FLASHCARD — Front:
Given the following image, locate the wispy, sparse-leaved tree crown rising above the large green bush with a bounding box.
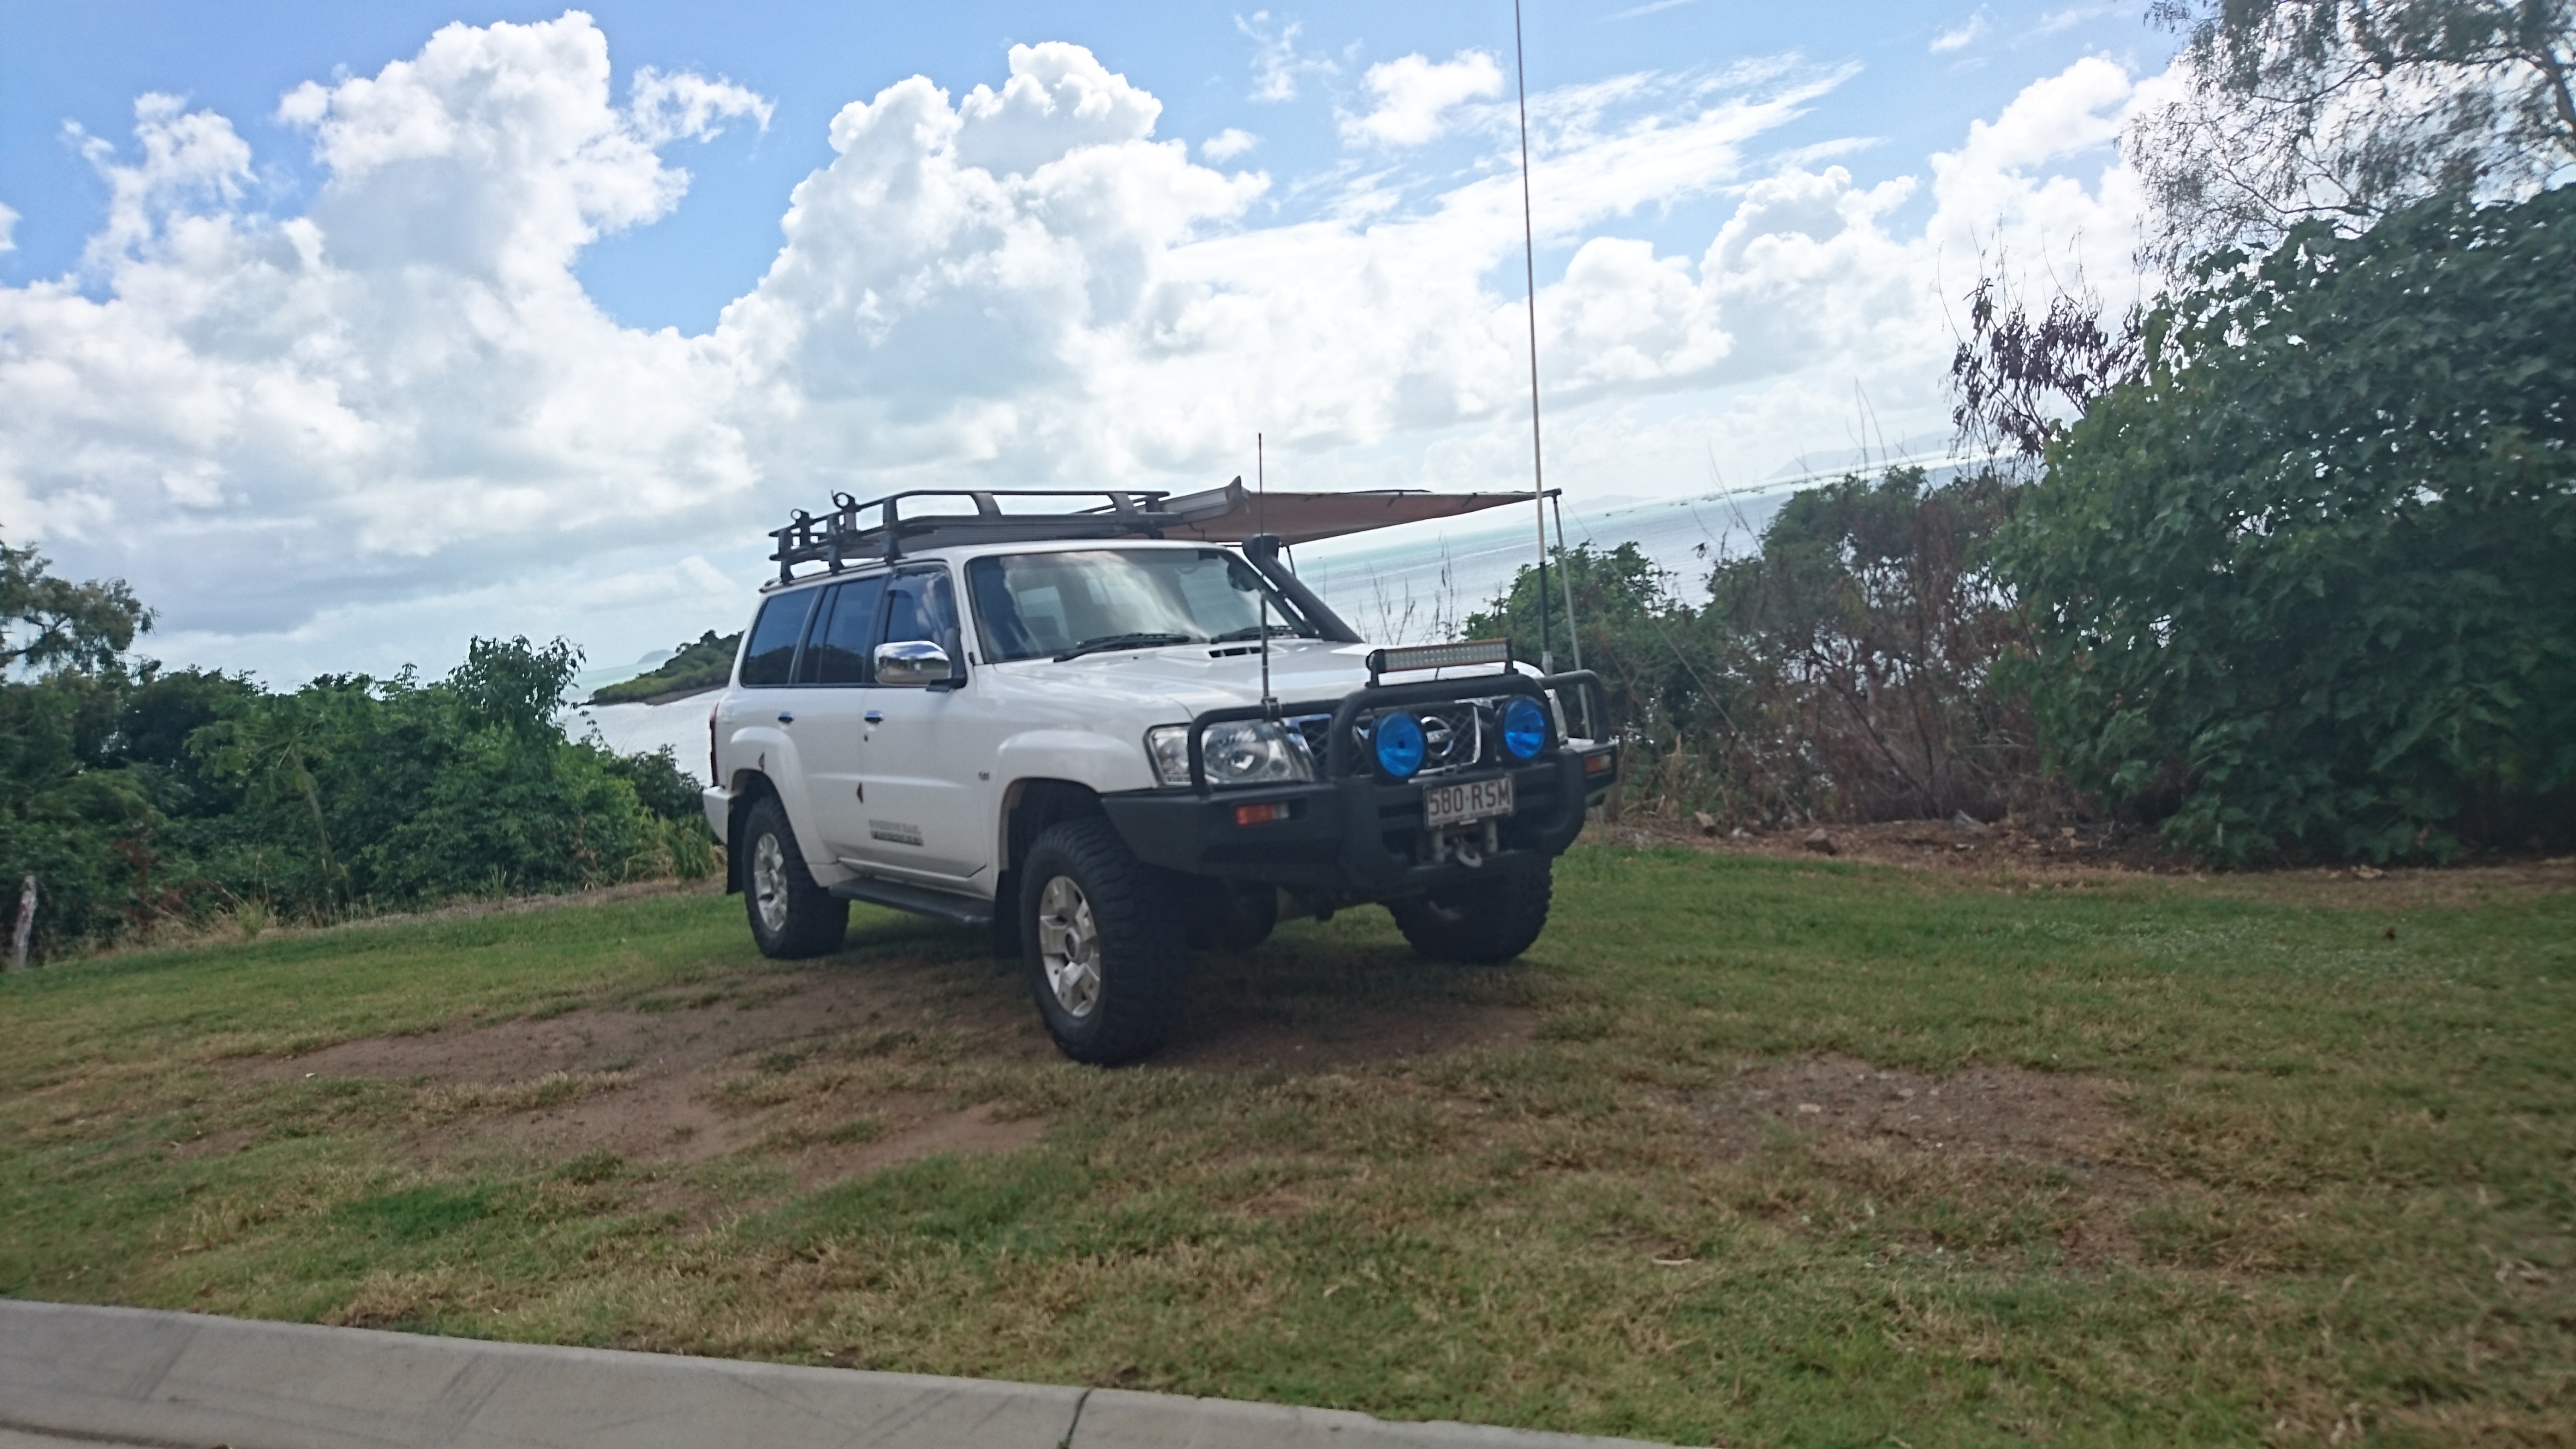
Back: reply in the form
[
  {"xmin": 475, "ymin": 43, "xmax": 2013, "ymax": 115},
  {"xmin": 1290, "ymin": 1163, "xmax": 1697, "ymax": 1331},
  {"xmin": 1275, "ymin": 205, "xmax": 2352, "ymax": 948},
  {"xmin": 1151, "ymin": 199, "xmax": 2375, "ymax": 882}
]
[{"xmin": 2128, "ymin": 0, "xmax": 2576, "ymax": 278}]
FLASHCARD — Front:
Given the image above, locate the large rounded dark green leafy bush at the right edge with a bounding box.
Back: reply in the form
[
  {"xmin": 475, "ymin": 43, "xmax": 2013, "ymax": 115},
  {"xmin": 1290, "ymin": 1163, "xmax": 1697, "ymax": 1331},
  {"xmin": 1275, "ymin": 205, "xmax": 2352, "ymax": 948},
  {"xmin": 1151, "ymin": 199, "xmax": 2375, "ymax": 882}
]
[{"xmin": 2004, "ymin": 191, "xmax": 2576, "ymax": 861}]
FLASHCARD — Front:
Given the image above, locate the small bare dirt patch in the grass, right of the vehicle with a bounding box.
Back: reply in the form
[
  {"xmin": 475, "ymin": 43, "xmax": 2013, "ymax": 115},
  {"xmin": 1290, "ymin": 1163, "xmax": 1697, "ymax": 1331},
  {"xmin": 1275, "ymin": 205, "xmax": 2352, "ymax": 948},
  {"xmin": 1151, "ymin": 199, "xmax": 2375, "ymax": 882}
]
[{"xmin": 1703, "ymin": 1041, "xmax": 2128, "ymax": 1168}]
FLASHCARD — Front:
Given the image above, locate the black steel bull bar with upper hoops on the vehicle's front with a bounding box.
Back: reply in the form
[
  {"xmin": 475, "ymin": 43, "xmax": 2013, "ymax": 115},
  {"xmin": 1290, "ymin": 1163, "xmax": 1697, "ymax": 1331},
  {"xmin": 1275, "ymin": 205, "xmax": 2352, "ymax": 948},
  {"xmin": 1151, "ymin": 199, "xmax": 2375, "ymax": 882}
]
[{"xmin": 1100, "ymin": 670, "xmax": 1618, "ymax": 905}]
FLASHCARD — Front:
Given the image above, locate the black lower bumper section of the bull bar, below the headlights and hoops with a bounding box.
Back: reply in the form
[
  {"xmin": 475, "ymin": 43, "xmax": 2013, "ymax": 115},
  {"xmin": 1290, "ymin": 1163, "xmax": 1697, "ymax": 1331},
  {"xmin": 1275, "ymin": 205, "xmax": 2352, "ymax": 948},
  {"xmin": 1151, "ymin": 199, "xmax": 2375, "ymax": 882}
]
[{"xmin": 1100, "ymin": 745, "xmax": 1618, "ymax": 902}]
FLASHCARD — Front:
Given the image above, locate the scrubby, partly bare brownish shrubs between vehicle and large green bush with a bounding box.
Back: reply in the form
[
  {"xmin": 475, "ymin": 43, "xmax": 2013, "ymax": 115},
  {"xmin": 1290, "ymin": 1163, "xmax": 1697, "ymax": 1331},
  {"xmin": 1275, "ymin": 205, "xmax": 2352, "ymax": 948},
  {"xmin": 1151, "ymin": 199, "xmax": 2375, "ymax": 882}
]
[{"xmin": 1466, "ymin": 467, "xmax": 2037, "ymax": 825}]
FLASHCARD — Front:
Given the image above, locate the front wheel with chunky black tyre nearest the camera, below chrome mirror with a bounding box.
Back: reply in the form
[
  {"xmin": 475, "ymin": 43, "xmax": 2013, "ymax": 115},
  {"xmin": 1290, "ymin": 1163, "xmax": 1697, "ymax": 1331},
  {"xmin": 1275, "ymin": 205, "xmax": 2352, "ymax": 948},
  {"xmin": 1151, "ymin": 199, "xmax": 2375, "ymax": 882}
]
[{"xmin": 1020, "ymin": 815, "xmax": 1187, "ymax": 1067}]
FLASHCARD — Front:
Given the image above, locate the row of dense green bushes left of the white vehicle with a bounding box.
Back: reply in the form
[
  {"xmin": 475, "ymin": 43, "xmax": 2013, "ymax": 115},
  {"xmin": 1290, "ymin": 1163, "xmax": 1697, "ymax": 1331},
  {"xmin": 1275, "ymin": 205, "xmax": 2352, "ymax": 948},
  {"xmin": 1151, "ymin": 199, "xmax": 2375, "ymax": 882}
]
[{"xmin": 0, "ymin": 549, "xmax": 714, "ymax": 954}]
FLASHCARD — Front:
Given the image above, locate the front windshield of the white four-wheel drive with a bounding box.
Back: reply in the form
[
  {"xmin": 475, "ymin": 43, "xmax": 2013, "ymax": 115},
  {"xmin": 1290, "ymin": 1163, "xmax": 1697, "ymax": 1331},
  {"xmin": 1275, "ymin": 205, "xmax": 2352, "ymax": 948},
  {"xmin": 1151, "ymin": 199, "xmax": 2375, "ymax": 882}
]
[{"xmin": 966, "ymin": 549, "xmax": 1319, "ymax": 663}]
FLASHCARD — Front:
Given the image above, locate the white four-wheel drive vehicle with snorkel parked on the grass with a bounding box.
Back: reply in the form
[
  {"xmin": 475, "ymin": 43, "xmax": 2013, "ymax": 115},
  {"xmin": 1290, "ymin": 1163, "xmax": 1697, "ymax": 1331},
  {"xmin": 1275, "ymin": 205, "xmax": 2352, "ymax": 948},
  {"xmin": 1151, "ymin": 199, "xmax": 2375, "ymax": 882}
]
[{"xmin": 706, "ymin": 480, "xmax": 1618, "ymax": 1062}]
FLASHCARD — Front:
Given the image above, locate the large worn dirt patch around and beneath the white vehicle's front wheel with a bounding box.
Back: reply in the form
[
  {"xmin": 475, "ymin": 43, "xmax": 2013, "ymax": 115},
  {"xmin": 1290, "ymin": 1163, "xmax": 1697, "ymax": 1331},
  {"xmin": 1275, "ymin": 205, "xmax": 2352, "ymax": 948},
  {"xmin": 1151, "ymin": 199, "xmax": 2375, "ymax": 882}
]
[{"xmin": 239, "ymin": 943, "xmax": 1538, "ymax": 1196}]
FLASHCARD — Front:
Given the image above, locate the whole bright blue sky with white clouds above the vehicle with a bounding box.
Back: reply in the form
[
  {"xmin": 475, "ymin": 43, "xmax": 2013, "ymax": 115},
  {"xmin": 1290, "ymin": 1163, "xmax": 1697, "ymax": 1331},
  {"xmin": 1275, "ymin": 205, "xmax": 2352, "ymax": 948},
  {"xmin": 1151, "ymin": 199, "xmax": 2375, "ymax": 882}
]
[{"xmin": 0, "ymin": 0, "xmax": 2174, "ymax": 686}]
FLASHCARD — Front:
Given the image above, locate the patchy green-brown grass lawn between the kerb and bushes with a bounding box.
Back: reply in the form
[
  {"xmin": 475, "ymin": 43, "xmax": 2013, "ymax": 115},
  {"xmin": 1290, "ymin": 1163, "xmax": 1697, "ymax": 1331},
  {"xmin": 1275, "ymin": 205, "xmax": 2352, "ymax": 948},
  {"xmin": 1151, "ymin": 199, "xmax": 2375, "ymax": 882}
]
[{"xmin": 0, "ymin": 846, "xmax": 2576, "ymax": 1446}]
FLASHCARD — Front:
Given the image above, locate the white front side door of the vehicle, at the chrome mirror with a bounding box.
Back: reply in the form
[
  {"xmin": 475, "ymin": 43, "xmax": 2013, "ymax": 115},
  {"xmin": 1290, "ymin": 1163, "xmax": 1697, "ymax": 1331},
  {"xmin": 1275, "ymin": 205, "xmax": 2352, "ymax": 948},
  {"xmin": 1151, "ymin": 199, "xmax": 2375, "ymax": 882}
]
[{"xmin": 858, "ymin": 565, "xmax": 994, "ymax": 887}]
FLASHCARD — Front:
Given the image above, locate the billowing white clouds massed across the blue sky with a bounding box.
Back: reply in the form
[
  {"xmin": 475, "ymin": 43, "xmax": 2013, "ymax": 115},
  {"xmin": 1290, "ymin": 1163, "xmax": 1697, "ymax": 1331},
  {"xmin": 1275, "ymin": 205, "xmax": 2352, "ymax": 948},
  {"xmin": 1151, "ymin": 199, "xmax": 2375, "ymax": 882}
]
[{"xmin": 0, "ymin": 15, "xmax": 2161, "ymax": 673}]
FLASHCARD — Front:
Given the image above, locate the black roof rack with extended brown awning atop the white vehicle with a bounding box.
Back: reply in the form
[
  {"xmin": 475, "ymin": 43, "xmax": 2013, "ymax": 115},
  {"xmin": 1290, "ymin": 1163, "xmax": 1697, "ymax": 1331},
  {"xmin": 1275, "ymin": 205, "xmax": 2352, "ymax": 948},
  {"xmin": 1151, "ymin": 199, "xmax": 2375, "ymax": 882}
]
[{"xmin": 770, "ymin": 477, "xmax": 1530, "ymax": 588}]
